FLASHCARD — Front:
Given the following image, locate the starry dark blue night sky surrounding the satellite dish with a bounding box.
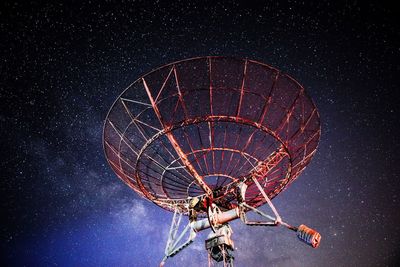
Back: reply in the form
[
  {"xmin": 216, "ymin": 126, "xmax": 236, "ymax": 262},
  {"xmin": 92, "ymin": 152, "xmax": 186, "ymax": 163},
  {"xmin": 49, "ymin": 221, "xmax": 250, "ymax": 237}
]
[{"xmin": 0, "ymin": 1, "xmax": 400, "ymax": 266}]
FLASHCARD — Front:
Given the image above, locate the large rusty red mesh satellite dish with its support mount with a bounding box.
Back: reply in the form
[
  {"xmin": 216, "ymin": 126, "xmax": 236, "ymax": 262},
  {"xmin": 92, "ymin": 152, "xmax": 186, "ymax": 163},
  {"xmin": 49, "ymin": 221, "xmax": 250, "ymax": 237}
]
[{"xmin": 104, "ymin": 57, "xmax": 321, "ymax": 266}]
